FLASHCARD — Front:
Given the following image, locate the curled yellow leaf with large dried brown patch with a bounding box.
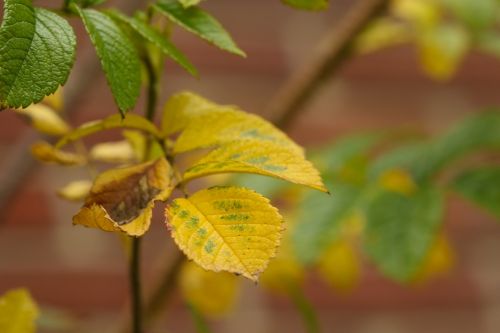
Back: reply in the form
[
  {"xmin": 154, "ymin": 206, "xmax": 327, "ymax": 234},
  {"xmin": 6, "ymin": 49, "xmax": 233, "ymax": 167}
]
[{"xmin": 73, "ymin": 158, "xmax": 172, "ymax": 236}]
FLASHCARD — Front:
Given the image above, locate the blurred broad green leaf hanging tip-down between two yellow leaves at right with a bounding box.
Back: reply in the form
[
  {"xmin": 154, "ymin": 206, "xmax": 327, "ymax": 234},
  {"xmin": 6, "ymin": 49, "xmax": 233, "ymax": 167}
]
[{"xmin": 364, "ymin": 187, "xmax": 443, "ymax": 282}]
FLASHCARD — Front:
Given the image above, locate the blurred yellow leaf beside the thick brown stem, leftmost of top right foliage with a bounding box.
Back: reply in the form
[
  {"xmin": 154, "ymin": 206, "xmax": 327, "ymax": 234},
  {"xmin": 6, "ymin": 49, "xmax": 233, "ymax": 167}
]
[{"xmin": 354, "ymin": 18, "xmax": 413, "ymax": 53}]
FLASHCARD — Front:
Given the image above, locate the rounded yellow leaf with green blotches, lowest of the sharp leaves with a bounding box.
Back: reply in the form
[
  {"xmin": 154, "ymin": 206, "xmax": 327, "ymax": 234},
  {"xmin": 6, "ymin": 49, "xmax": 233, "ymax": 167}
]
[{"xmin": 165, "ymin": 187, "xmax": 283, "ymax": 281}]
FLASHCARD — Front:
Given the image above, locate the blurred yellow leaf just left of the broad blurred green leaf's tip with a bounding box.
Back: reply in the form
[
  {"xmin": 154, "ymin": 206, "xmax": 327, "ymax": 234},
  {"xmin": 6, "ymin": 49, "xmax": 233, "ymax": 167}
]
[{"xmin": 318, "ymin": 240, "xmax": 361, "ymax": 292}]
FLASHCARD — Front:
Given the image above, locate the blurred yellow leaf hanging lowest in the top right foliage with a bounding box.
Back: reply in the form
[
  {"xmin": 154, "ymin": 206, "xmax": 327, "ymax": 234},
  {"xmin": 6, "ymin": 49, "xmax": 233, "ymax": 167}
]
[{"xmin": 417, "ymin": 24, "xmax": 469, "ymax": 80}]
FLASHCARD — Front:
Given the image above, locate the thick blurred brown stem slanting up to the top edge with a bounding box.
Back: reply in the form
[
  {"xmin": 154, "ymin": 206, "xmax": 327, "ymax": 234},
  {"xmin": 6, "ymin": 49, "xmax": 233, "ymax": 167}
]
[{"xmin": 265, "ymin": 0, "xmax": 389, "ymax": 129}]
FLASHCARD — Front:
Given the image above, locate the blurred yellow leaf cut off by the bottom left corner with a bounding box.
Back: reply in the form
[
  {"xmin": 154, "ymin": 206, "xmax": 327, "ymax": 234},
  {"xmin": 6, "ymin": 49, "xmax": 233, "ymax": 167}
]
[{"xmin": 0, "ymin": 289, "xmax": 39, "ymax": 333}]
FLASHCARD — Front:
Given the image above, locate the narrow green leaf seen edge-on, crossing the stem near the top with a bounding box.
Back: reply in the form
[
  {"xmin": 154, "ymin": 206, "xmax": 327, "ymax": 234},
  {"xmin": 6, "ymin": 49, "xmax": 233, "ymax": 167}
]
[{"xmin": 110, "ymin": 11, "xmax": 198, "ymax": 76}]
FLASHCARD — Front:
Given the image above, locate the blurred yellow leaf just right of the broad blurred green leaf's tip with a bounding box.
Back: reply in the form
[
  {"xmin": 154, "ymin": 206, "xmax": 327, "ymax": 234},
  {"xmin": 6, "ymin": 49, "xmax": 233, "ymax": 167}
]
[{"xmin": 412, "ymin": 234, "xmax": 455, "ymax": 284}]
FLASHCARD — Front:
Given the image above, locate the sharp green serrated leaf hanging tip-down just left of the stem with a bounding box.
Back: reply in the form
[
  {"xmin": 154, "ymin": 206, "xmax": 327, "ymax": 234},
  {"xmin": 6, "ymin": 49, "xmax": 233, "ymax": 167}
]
[{"xmin": 74, "ymin": 5, "xmax": 141, "ymax": 114}]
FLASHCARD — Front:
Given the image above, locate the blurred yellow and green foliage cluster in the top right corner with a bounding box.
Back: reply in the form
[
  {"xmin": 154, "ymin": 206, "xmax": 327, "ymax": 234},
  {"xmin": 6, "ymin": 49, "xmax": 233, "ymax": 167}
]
[{"xmin": 355, "ymin": 0, "xmax": 500, "ymax": 80}]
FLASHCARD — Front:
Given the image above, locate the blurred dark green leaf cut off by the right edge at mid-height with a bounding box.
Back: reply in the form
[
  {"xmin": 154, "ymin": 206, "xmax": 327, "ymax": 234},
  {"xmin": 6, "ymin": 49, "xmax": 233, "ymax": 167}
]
[{"xmin": 452, "ymin": 167, "xmax": 500, "ymax": 218}]
